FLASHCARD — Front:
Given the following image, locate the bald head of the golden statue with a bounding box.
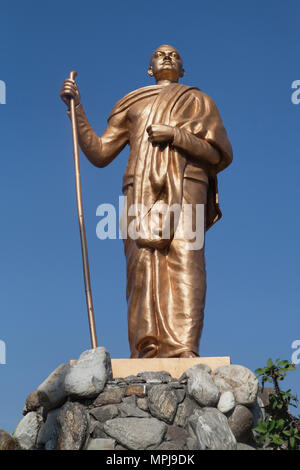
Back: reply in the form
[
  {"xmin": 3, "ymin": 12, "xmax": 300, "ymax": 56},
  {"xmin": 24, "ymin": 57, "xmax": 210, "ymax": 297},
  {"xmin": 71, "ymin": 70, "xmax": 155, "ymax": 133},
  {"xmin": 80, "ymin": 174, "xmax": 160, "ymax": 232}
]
[{"xmin": 148, "ymin": 44, "xmax": 184, "ymax": 82}]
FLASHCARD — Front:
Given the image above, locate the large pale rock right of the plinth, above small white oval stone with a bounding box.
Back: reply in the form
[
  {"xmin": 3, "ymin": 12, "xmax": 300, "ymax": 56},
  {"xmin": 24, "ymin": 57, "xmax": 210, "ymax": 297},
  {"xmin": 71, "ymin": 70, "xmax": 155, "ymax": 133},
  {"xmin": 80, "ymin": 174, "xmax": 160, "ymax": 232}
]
[{"xmin": 212, "ymin": 365, "xmax": 258, "ymax": 405}]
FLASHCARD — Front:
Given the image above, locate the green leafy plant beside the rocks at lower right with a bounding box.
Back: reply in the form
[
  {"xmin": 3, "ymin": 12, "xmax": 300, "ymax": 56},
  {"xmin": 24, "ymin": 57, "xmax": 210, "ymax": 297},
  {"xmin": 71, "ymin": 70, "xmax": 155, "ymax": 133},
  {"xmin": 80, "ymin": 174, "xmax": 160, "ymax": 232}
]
[{"xmin": 254, "ymin": 359, "xmax": 300, "ymax": 450}]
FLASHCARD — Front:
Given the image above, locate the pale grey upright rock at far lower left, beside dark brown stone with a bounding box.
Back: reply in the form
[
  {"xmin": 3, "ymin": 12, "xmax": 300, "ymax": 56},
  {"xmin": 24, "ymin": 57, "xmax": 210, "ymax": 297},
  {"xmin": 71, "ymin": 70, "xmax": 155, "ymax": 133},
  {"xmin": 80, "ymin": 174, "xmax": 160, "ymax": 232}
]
[{"xmin": 13, "ymin": 411, "xmax": 42, "ymax": 450}]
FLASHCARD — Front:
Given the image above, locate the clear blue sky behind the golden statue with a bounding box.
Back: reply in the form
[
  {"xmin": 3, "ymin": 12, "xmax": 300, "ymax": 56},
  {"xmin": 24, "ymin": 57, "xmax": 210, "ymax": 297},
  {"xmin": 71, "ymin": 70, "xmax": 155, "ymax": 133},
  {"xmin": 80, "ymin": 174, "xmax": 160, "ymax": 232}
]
[{"xmin": 0, "ymin": 0, "xmax": 300, "ymax": 431}]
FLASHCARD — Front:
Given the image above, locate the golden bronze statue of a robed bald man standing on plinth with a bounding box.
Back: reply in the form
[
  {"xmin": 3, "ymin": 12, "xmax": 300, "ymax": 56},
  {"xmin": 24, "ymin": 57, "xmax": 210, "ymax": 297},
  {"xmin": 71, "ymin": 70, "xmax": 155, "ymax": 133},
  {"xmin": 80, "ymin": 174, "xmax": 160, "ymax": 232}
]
[{"xmin": 61, "ymin": 45, "xmax": 232, "ymax": 358}]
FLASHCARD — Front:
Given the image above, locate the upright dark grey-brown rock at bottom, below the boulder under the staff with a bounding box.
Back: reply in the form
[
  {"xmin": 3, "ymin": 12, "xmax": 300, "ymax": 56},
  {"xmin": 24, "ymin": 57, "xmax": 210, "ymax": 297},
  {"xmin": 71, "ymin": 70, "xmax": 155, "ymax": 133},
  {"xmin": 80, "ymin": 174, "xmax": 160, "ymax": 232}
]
[{"xmin": 56, "ymin": 402, "xmax": 89, "ymax": 450}]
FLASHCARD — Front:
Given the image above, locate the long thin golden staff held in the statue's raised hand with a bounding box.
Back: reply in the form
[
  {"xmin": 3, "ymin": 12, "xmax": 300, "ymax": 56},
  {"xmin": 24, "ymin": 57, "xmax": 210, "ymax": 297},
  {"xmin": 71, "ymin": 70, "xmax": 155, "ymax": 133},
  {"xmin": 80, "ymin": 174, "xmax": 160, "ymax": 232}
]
[{"xmin": 70, "ymin": 71, "xmax": 97, "ymax": 348}]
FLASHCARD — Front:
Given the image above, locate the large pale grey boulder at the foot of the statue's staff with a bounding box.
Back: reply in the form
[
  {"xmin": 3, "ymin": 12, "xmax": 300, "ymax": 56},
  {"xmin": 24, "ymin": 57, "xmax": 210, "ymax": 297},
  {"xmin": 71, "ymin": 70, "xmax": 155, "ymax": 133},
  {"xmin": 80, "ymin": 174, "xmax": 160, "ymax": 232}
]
[{"xmin": 65, "ymin": 347, "xmax": 112, "ymax": 399}]
